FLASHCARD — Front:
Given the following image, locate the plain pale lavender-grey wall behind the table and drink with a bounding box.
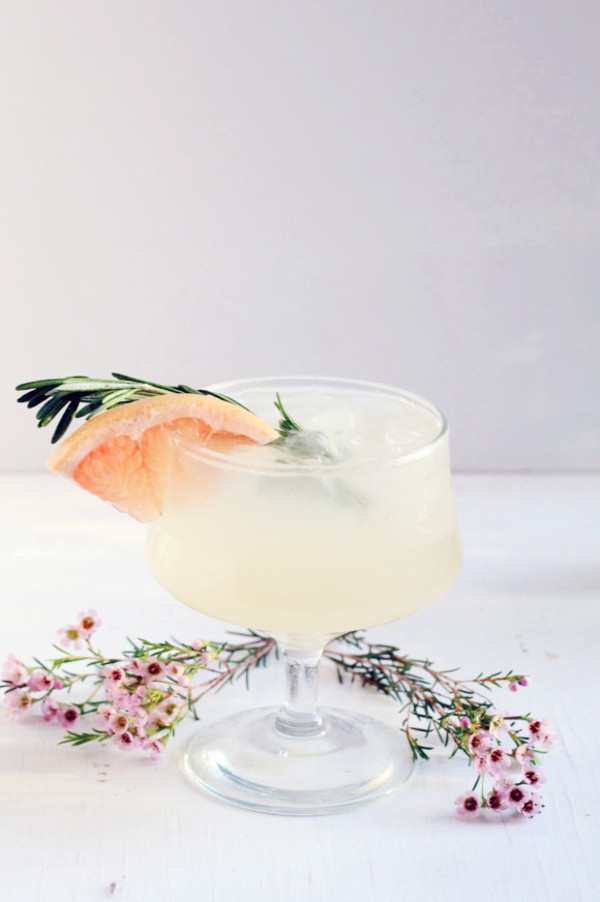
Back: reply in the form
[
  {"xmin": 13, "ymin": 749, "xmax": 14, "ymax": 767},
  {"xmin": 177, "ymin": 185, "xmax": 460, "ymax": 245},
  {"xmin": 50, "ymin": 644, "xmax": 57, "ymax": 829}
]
[{"xmin": 0, "ymin": 0, "xmax": 600, "ymax": 470}]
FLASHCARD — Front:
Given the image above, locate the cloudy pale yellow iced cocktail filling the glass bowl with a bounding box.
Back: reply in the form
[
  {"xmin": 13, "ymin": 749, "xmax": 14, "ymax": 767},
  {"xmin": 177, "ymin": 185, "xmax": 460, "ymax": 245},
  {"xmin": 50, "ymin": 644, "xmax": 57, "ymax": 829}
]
[{"xmin": 148, "ymin": 380, "xmax": 461, "ymax": 641}]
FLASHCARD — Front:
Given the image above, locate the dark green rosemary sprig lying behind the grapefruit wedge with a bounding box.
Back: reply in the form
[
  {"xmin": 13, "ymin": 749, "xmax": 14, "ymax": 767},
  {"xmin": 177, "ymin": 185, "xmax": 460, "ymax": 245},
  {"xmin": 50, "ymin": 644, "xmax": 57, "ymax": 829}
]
[{"xmin": 16, "ymin": 373, "xmax": 286, "ymax": 444}]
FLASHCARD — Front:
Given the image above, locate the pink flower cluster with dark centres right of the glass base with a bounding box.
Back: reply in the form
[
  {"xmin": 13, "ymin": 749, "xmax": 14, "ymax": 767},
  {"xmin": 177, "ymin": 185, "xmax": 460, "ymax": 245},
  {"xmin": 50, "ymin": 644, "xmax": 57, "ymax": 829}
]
[{"xmin": 455, "ymin": 712, "xmax": 553, "ymax": 817}]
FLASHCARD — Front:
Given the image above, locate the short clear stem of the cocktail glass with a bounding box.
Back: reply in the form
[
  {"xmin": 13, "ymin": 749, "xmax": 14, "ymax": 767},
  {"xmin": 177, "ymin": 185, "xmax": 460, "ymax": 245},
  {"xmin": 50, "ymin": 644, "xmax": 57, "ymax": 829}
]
[{"xmin": 275, "ymin": 645, "xmax": 324, "ymax": 736}]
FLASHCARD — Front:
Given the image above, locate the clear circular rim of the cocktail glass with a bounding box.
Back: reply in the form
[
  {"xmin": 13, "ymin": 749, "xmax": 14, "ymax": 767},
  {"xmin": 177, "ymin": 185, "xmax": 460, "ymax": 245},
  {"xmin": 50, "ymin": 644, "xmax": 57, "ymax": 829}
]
[{"xmin": 174, "ymin": 375, "xmax": 449, "ymax": 476}]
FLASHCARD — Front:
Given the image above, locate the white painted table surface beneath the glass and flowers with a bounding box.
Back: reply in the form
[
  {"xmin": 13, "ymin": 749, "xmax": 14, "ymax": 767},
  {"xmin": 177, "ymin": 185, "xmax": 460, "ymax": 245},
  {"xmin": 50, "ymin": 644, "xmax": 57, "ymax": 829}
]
[{"xmin": 0, "ymin": 474, "xmax": 600, "ymax": 902}]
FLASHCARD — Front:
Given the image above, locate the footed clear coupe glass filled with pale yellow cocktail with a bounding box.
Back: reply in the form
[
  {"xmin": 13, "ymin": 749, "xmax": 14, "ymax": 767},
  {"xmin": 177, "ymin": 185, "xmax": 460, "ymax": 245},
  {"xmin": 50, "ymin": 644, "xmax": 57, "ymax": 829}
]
[{"xmin": 148, "ymin": 377, "xmax": 461, "ymax": 814}]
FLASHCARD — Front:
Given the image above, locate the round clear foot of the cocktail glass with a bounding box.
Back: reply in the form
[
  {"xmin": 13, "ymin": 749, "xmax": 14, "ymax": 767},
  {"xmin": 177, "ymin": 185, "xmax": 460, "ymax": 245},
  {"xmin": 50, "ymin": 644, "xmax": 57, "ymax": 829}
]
[{"xmin": 181, "ymin": 708, "xmax": 413, "ymax": 815}]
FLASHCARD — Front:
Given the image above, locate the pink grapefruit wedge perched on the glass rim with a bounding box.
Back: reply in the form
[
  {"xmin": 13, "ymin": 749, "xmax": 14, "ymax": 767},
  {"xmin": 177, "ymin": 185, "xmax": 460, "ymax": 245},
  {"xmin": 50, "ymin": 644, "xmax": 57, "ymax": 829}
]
[{"xmin": 46, "ymin": 393, "xmax": 278, "ymax": 523}]
